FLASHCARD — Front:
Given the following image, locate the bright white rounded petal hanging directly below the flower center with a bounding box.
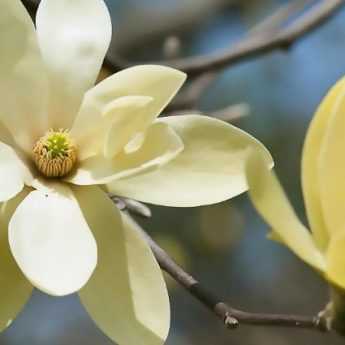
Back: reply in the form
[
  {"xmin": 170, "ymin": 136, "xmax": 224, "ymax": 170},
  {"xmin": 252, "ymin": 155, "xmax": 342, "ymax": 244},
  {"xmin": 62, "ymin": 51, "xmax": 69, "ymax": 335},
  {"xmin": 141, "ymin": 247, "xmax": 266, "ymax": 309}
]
[{"xmin": 9, "ymin": 184, "xmax": 97, "ymax": 296}]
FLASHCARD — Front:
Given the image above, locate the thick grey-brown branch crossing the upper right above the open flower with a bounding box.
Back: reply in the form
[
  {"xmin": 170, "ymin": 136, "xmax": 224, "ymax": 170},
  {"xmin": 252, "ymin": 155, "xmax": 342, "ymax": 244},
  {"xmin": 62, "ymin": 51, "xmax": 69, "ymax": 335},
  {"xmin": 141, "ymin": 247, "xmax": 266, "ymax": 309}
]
[{"xmin": 106, "ymin": 0, "xmax": 345, "ymax": 76}]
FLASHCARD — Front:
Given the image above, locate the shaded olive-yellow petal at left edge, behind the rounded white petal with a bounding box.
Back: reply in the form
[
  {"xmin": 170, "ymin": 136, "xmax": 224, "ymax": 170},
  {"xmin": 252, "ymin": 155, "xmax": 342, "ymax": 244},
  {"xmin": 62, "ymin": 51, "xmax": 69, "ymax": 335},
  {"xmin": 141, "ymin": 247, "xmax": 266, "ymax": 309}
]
[{"xmin": 0, "ymin": 189, "xmax": 32, "ymax": 331}]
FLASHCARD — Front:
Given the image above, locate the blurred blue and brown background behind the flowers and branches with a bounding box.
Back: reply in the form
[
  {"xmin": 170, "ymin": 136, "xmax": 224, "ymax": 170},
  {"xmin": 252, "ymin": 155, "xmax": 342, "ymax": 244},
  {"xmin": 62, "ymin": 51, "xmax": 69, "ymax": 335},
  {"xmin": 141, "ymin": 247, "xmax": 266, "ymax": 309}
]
[{"xmin": 4, "ymin": 0, "xmax": 345, "ymax": 345}]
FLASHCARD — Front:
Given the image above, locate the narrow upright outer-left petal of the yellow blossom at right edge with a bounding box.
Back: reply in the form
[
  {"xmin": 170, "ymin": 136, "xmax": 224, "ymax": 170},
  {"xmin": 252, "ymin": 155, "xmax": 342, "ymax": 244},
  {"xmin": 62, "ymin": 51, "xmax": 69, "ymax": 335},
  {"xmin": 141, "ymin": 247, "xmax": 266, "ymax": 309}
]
[{"xmin": 302, "ymin": 78, "xmax": 345, "ymax": 250}]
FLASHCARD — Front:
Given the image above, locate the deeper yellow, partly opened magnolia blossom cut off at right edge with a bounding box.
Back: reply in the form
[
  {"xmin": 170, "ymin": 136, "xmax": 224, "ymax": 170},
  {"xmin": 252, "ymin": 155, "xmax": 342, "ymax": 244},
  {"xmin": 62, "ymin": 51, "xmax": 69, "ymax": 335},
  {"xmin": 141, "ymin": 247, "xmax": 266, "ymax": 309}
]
[{"xmin": 246, "ymin": 79, "xmax": 345, "ymax": 290}]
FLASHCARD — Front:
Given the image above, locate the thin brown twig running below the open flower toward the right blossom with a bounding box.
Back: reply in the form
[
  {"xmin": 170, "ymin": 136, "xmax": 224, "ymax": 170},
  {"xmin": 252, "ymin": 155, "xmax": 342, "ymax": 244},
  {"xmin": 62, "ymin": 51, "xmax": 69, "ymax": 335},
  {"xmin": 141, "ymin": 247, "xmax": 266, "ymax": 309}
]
[{"xmin": 128, "ymin": 215, "xmax": 329, "ymax": 331}]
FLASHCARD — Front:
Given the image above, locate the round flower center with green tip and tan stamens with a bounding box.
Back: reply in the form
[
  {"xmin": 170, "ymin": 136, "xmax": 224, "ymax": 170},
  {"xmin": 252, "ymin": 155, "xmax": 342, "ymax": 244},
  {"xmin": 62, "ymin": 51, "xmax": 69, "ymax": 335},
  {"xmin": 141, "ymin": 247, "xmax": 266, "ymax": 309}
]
[{"xmin": 32, "ymin": 129, "xmax": 77, "ymax": 177}]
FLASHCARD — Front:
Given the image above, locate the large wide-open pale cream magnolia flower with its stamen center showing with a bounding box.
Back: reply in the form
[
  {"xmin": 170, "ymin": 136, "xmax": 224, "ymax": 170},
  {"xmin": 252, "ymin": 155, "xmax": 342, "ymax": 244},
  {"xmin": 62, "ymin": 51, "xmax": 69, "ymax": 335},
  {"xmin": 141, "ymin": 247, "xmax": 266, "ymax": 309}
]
[{"xmin": 0, "ymin": 0, "xmax": 272, "ymax": 345}]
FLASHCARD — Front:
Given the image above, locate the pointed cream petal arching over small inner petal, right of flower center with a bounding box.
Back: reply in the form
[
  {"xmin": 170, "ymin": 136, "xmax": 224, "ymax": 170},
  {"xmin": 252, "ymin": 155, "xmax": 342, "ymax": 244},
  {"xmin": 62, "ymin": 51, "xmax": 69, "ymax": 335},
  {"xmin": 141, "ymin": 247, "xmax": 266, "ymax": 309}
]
[{"xmin": 73, "ymin": 65, "xmax": 186, "ymax": 135}]
